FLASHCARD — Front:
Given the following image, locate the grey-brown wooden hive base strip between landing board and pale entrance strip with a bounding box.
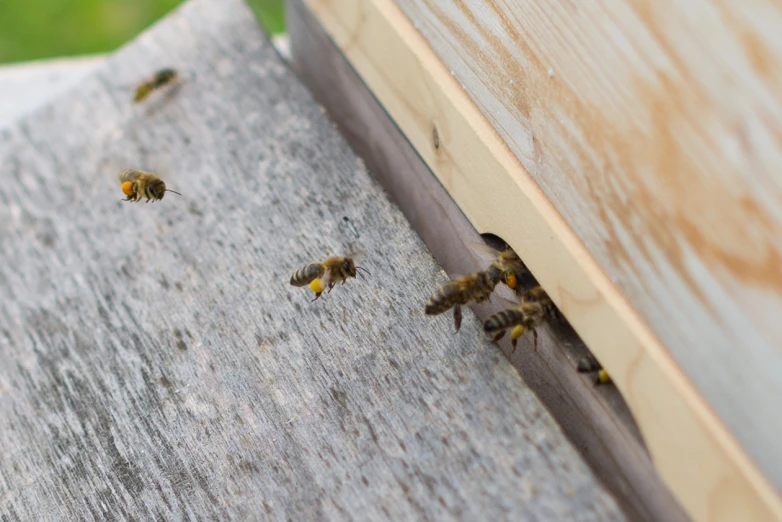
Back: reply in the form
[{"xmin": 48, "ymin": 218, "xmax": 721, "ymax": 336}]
[{"xmin": 286, "ymin": 0, "xmax": 687, "ymax": 522}]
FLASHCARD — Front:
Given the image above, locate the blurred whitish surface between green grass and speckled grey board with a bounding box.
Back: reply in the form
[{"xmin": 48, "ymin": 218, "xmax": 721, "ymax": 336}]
[{"xmin": 0, "ymin": 55, "xmax": 103, "ymax": 125}]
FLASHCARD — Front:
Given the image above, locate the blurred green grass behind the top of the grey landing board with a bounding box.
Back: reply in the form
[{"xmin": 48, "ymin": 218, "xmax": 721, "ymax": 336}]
[{"xmin": 0, "ymin": 0, "xmax": 285, "ymax": 63}]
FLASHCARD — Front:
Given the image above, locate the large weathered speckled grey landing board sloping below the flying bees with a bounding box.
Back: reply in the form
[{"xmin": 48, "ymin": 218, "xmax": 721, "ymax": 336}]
[{"xmin": 0, "ymin": 0, "xmax": 623, "ymax": 520}]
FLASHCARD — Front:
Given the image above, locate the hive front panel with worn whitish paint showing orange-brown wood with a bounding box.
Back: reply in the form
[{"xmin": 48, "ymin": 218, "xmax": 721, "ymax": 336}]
[{"xmin": 396, "ymin": 0, "xmax": 782, "ymax": 492}]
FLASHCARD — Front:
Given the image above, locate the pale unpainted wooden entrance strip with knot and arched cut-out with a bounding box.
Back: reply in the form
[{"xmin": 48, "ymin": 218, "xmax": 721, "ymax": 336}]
[{"xmin": 304, "ymin": 0, "xmax": 782, "ymax": 521}]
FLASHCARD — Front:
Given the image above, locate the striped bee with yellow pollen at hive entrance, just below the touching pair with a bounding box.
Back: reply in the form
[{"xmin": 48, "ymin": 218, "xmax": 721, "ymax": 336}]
[{"xmin": 483, "ymin": 286, "xmax": 558, "ymax": 353}]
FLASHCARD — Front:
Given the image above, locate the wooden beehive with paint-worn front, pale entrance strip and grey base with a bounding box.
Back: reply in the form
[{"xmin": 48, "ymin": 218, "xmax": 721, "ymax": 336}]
[{"xmin": 288, "ymin": 0, "xmax": 782, "ymax": 521}]
